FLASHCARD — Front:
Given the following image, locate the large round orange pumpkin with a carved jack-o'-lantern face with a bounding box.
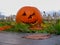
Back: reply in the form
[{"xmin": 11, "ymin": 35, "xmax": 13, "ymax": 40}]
[{"xmin": 16, "ymin": 6, "xmax": 42, "ymax": 24}]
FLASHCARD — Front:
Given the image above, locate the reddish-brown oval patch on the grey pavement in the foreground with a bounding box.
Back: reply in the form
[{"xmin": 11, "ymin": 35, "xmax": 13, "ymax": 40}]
[{"xmin": 23, "ymin": 34, "xmax": 51, "ymax": 40}]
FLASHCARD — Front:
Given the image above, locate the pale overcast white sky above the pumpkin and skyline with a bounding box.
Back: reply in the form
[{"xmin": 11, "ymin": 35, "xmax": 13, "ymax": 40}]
[{"xmin": 0, "ymin": 0, "xmax": 60, "ymax": 16}]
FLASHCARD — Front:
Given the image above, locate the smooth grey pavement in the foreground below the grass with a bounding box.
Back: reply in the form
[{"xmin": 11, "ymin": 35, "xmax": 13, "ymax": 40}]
[{"xmin": 0, "ymin": 32, "xmax": 60, "ymax": 45}]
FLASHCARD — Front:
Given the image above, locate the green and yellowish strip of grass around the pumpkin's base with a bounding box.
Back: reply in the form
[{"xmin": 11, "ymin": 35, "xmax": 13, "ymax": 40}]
[{"xmin": 0, "ymin": 20, "xmax": 60, "ymax": 35}]
